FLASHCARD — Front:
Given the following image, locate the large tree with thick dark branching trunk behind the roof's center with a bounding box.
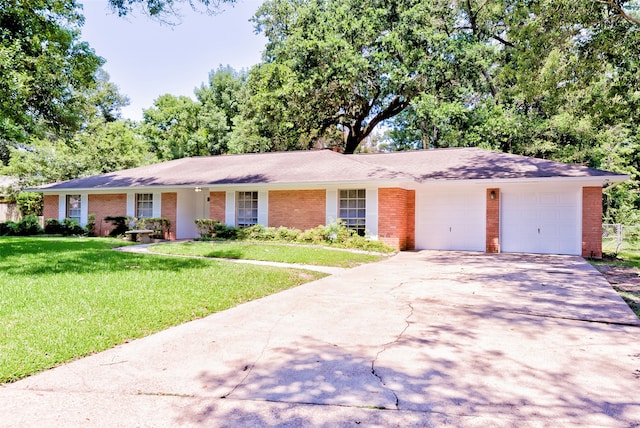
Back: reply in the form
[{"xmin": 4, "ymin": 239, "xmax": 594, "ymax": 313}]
[{"xmin": 255, "ymin": 0, "xmax": 476, "ymax": 153}]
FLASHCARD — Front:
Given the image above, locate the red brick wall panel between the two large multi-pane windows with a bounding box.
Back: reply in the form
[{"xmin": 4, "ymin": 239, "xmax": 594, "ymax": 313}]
[{"xmin": 269, "ymin": 190, "xmax": 327, "ymax": 230}]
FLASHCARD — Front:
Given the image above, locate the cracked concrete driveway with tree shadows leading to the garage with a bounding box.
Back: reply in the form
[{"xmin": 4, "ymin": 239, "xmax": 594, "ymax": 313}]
[{"xmin": 0, "ymin": 252, "xmax": 640, "ymax": 427}]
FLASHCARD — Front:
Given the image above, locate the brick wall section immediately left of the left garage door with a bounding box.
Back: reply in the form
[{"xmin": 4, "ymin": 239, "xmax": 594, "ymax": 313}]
[{"xmin": 378, "ymin": 188, "xmax": 416, "ymax": 250}]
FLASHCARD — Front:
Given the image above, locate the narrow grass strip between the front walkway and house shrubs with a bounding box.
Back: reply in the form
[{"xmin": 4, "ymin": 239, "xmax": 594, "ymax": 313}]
[{"xmin": 149, "ymin": 241, "xmax": 388, "ymax": 268}]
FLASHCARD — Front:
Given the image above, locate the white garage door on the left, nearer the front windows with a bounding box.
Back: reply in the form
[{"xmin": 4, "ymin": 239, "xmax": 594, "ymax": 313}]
[{"xmin": 416, "ymin": 188, "xmax": 486, "ymax": 251}]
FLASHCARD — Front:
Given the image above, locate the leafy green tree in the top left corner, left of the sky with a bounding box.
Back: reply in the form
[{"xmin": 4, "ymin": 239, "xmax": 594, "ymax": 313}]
[{"xmin": 0, "ymin": 0, "xmax": 103, "ymax": 142}]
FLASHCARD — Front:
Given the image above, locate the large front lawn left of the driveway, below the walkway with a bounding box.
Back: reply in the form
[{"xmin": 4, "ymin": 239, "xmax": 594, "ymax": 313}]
[{"xmin": 0, "ymin": 237, "xmax": 324, "ymax": 383}]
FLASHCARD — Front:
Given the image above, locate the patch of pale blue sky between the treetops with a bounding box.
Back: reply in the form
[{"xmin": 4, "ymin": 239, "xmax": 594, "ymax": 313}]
[{"xmin": 82, "ymin": 0, "xmax": 265, "ymax": 120}]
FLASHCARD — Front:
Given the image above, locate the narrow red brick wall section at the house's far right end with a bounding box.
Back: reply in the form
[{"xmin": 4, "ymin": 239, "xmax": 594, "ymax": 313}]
[{"xmin": 582, "ymin": 187, "xmax": 602, "ymax": 259}]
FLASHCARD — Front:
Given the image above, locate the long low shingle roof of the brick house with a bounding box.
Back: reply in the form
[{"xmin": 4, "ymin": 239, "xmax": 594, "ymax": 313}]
[{"xmin": 39, "ymin": 148, "xmax": 627, "ymax": 190}]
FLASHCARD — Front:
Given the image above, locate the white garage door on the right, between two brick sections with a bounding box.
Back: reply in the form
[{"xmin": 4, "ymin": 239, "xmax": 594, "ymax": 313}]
[{"xmin": 500, "ymin": 188, "xmax": 581, "ymax": 254}]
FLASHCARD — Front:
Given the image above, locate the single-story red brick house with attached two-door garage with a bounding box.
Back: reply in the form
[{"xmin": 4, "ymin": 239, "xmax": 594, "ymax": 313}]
[{"xmin": 37, "ymin": 148, "xmax": 629, "ymax": 257}]
